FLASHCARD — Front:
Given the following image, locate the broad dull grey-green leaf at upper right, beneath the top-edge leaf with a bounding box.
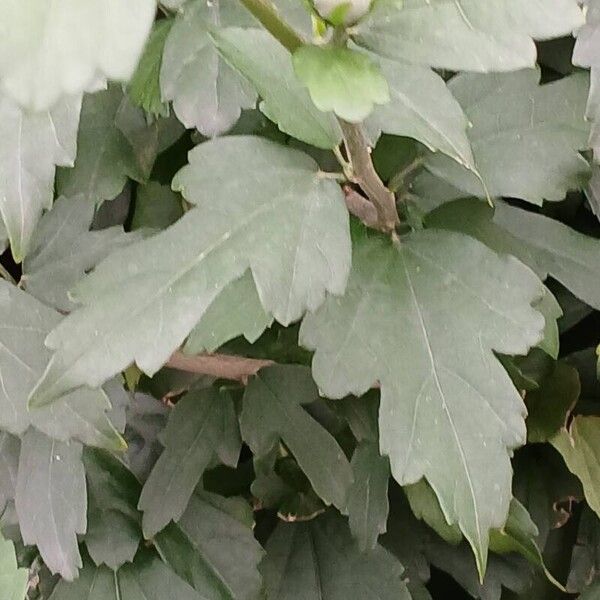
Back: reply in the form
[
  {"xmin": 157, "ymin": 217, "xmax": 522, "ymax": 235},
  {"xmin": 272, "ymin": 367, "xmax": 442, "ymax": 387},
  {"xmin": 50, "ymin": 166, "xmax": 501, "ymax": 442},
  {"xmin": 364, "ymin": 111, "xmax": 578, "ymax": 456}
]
[{"xmin": 426, "ymin": 70, "xmax": 591, "ymax": 204}]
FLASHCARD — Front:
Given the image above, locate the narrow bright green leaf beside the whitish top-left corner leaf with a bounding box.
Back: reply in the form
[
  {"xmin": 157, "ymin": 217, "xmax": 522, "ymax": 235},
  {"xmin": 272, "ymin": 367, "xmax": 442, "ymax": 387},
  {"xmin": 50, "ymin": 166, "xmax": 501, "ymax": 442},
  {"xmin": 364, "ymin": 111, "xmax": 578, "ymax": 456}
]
[{"xmin": 127, "ymin": 19, "xmax": 175, "ymax": 117}]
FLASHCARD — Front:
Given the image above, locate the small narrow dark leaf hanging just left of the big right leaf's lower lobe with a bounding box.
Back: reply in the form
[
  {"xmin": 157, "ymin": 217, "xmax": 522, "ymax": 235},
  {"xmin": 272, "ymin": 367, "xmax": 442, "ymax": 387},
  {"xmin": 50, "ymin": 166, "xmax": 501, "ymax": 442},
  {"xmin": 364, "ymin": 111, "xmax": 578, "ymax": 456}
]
[{"xmin": 345, "ymin": 442, "xmax": 390, "ymax": 552}]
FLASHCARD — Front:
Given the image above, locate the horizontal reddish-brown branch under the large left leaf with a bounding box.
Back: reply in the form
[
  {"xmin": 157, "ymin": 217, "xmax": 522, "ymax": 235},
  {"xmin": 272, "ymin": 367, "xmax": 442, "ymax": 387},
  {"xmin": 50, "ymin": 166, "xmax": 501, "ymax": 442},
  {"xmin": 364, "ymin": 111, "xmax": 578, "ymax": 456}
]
[{"xmin": 165, "ymin": 351, "xmax": 274, "ymax": 383}]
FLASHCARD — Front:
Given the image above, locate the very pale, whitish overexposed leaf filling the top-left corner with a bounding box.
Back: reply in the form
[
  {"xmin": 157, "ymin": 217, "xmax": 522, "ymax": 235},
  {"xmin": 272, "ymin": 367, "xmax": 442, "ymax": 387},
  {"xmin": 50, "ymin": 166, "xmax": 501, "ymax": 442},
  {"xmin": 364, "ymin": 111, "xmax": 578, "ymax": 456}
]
[{"xmin": 0, "ymin": 0, "xmax": 156, "ymax": 111}]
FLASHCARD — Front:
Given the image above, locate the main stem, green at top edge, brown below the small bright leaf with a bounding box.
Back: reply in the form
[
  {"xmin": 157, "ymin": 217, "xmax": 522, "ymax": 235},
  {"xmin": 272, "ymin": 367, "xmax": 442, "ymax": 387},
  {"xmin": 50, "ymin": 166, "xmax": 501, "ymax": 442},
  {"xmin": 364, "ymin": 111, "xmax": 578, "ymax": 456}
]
[{"xmin": 240, "ymin": 0, "xmax": 399, "ymax": 233}]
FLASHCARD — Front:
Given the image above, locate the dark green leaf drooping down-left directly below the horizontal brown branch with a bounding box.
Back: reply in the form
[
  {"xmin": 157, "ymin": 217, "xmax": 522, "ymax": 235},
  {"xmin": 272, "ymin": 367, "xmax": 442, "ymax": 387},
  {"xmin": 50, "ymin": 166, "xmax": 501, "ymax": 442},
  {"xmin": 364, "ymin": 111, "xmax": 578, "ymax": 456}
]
[{"xmin": 139, "ymin": 388, "xmax": 241, "ymax": 538}]
